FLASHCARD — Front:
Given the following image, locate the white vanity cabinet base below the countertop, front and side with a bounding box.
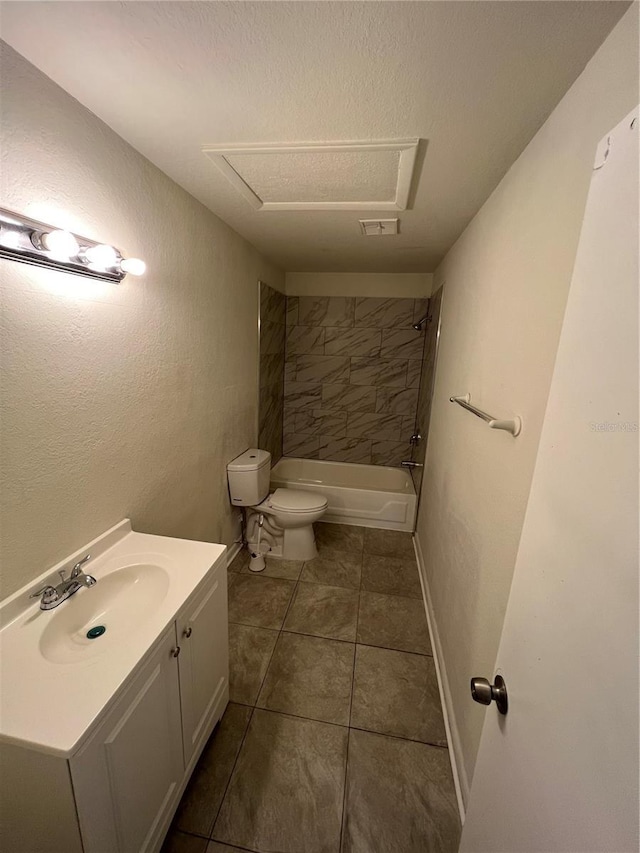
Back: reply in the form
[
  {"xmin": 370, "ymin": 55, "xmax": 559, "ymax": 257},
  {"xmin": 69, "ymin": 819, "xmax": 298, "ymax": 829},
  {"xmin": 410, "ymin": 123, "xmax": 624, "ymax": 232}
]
[{"xmin": 0, "ymin": 546, "xmax": 229, "ymax": 853}]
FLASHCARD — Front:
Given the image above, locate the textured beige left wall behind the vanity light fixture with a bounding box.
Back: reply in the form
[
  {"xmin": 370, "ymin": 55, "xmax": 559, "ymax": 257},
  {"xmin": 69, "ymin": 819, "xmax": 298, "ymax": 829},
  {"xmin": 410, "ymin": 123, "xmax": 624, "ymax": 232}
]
[{"xmin": 0, "ymin": 46, "xmax": 284, "ymax": 595}]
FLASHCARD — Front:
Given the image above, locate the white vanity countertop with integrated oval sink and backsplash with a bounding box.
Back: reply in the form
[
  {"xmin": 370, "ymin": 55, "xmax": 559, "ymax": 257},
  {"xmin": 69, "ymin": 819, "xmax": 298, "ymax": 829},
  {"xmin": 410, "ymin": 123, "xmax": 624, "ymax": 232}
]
[{"xmin": 0, "ymin": 519, "xmax": 227, "ymax": 758}]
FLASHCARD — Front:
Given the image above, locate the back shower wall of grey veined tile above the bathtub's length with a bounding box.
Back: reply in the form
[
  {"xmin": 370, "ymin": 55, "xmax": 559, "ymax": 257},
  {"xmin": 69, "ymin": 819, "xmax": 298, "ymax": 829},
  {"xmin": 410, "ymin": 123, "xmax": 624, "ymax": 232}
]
[{"xmin": 284, "ymin": 296, "xmax": 427, "ymax": 465}]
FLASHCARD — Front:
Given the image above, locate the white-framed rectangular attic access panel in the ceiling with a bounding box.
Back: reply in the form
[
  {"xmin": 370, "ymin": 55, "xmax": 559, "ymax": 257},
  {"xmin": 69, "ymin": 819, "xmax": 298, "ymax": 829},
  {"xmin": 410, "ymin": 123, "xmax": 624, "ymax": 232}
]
[{"xmin": 202, "ymin": 139, "xmax": 419, "ymax": 211}]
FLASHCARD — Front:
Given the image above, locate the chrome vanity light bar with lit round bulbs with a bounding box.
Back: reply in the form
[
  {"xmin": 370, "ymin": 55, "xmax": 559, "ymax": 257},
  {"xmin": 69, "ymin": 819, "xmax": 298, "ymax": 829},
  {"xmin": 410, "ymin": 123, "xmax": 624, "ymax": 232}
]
[{"xmin": 0, "ymin": 208, "xmax": 146, "ymax": 284}]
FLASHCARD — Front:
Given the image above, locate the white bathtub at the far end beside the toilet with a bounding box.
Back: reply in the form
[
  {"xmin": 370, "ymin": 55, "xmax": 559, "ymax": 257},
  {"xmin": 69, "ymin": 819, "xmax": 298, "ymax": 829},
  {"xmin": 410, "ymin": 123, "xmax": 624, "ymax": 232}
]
[{"xmin": 271, "ymin": 457, "xmax": 416, "ymax": 531}]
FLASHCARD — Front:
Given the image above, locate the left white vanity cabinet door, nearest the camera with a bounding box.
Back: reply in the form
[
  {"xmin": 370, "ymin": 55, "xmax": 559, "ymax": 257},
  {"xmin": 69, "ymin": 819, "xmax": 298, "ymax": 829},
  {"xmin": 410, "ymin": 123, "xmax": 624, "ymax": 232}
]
[{"xmin": 70, "ymin": 624, "xmax": 184, "ymax": 853}]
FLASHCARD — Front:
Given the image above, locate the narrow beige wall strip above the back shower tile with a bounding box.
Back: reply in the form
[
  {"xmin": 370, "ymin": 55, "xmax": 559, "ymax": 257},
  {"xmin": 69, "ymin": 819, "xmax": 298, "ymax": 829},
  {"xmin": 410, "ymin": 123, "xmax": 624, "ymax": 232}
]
[{"xmin": 286, "ymin": 274, "xmax": 433, "ymax": 299}]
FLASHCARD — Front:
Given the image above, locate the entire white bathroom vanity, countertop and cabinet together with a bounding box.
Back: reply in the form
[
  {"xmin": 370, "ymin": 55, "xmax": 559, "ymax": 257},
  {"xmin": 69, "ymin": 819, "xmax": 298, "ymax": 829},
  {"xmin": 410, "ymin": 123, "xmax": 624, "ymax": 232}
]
[{"xmin": 0, "ymin": 520, "xmax": 229, "ymax": 853}]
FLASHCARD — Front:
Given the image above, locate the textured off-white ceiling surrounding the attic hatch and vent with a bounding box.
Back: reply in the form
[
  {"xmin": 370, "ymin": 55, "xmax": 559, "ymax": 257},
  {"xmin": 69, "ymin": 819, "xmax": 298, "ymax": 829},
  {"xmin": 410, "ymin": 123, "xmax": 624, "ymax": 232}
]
[{"xmin": 0, "ymin": 0, "xmax": 628, "ymax": 272}]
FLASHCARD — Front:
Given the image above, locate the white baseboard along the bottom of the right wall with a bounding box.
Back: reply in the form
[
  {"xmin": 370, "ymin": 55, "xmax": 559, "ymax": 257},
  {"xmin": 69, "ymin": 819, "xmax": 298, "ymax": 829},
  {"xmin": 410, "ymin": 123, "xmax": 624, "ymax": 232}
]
[{"xmin": 413, "ymin": 536, "xmax": 469, "ymax": 823}]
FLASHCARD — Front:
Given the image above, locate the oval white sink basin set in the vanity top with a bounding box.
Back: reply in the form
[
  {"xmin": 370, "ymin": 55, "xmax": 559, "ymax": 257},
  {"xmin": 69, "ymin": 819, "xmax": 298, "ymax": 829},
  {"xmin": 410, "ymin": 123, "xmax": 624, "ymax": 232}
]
[{"xmin": 40, "ymin": 563, "xmax": 169, "ymax": 663}]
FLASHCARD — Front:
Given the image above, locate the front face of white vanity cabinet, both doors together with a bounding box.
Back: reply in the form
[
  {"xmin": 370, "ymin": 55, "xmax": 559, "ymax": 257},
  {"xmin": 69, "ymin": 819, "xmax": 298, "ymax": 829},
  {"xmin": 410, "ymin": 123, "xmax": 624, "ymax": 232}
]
[{"xmin": 69, "ymin": 563, "xmax": 229, "ymax": 853}]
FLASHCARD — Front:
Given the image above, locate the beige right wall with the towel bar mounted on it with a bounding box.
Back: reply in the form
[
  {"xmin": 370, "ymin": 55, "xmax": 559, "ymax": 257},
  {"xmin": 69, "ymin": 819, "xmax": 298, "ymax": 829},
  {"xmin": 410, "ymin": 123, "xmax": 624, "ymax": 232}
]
[{"xmin": 417, "ymin": 5, "xmax": 638, "ymax": 804}]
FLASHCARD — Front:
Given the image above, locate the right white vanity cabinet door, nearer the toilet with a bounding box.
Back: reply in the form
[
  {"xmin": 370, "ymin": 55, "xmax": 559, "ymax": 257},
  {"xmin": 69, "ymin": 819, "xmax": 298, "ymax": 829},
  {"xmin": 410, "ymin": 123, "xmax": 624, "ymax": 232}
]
[{"xmin": 176, "ymin": 558, "xmax": 229, "ymax": 766}]
